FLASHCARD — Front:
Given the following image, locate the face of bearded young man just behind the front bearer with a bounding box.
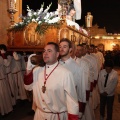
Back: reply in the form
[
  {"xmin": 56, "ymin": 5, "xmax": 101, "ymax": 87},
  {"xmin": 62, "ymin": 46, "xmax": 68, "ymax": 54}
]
[{"xmin": 59, "ymin": 42, "xmax": 71, "ymax": 57}]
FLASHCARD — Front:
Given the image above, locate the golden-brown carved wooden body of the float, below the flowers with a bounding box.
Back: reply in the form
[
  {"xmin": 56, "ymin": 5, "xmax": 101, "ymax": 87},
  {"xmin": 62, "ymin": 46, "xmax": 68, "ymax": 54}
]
[{"xmin": 8, "ymin": 21, "xmax": 89, "ymax": 51}]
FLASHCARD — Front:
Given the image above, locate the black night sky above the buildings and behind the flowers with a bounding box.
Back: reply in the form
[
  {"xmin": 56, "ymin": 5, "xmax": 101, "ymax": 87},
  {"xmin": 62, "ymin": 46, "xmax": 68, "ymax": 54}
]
[{"xmin": 23, "ymin": 0, "xmax": 120, "ymax": 33}]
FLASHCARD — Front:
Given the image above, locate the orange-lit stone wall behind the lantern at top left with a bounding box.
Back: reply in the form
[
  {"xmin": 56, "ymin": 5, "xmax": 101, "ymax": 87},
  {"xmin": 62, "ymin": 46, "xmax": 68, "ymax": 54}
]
[{"xmin": 0, "ymin": 0, "xmax": 22, "ymax": 45}]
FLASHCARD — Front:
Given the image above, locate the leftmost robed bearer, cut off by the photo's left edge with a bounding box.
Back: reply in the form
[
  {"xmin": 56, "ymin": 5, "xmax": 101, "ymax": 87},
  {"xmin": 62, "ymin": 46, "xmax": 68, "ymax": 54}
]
[{"xmin": 0, "ymin": 45, "xmax": 13, "ymax": 115}]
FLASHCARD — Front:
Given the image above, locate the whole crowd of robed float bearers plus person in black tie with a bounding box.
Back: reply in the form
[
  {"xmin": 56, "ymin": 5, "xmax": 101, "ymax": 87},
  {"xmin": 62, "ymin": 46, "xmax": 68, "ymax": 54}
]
[{"xmin": 0, "ymin": 38, "xmax": 118, "ymax": 120}]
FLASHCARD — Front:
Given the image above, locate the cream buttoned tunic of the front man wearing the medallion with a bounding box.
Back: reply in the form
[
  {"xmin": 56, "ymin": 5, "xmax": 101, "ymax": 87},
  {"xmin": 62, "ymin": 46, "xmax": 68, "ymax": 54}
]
[{"xmin": 25, "ymin": 62, "xmax": 79, "ymax": 120}]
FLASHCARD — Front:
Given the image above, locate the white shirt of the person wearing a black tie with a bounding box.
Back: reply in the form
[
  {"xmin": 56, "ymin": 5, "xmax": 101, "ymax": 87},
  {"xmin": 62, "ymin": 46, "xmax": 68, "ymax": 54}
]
[{"xmin": 98, "ymin": 69, "xmax": 118, "ymax": 96}]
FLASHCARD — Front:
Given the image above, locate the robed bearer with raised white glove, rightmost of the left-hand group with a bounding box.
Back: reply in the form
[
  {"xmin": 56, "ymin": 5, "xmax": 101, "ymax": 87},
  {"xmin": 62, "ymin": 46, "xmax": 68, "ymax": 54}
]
[{"xmin": 11, "ymin": 52, "xmax": 27, "ymax": 100}]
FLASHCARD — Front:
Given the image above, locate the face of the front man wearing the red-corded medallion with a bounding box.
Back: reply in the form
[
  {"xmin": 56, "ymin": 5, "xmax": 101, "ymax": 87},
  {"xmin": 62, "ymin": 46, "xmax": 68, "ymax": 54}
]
[{"xmin": 43, "ymin": 45, "xmax": 59, "ymax": 65}]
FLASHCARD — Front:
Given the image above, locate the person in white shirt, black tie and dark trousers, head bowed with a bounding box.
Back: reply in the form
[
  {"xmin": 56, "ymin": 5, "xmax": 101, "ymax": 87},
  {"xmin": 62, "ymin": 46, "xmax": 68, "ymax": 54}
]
[{"xmin": 98, "ymin": 59, "xmax": 118, "ymax": 120}]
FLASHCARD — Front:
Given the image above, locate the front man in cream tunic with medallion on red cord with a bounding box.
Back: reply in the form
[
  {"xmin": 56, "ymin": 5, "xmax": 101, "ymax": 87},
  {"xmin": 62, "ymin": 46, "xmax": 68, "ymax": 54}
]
[{"xmin": 24, "ymin": 42, "xmax": 79, "ymax": 120}]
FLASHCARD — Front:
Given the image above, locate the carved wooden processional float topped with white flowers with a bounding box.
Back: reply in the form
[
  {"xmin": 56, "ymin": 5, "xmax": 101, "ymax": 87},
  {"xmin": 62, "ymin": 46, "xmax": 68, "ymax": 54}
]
[{"xmin": 7, "ymin": 0, "xmax": 90, "ymax": 51}]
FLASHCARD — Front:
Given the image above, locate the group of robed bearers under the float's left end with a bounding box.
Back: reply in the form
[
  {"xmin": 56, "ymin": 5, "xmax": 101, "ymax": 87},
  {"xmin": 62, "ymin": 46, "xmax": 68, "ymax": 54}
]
[{"xmin": 0, "ymin": 44, "xmax": 27, "ymax": 115}]
